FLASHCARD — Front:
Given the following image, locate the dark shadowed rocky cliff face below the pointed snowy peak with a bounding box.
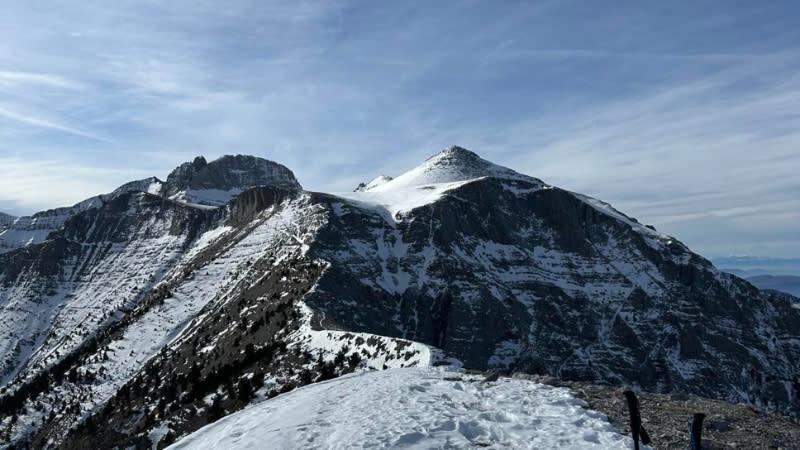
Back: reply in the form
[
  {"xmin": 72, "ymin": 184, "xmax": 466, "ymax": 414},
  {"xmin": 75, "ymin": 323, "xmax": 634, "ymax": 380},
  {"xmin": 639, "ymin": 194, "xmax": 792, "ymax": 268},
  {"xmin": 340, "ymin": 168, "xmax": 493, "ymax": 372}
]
[{"xmin": 306, "ymin": 163, "xmax": 800, "ymax": 411}]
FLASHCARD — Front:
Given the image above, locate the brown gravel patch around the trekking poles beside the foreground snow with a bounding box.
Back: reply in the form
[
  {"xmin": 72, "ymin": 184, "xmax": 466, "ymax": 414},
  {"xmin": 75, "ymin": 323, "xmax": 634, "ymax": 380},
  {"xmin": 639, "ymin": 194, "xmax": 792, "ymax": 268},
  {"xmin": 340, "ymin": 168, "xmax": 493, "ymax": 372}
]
[{"xmin": 513, "ymin": 374, "xmax": 800, "ymax": 450}]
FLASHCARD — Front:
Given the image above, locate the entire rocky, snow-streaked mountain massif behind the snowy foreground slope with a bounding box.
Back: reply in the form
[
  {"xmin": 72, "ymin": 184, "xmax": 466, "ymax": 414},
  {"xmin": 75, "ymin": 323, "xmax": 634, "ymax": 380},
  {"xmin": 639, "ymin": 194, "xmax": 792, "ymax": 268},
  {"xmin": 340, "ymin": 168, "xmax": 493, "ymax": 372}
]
[{"xmin": 0, "ymin": 147, "xmax": 800, "ymax": 448}]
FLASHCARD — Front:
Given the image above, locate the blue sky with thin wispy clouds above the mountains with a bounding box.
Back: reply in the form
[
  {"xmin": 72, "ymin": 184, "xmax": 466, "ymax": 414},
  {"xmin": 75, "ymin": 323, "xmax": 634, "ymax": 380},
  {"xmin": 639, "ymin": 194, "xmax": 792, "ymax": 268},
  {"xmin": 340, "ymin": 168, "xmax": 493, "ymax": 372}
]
[{"xmin": 0, "ymin": 0, "xmax": 800, "ymax": 257}]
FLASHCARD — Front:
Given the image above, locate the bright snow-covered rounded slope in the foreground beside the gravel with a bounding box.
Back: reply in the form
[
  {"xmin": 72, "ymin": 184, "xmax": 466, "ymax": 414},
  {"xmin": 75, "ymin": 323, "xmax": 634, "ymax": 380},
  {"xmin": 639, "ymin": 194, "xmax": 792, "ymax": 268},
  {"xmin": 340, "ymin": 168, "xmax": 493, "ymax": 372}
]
[{"xmin": 169, "ymin": 367, "xmax": 633, "ymax": 450}]
